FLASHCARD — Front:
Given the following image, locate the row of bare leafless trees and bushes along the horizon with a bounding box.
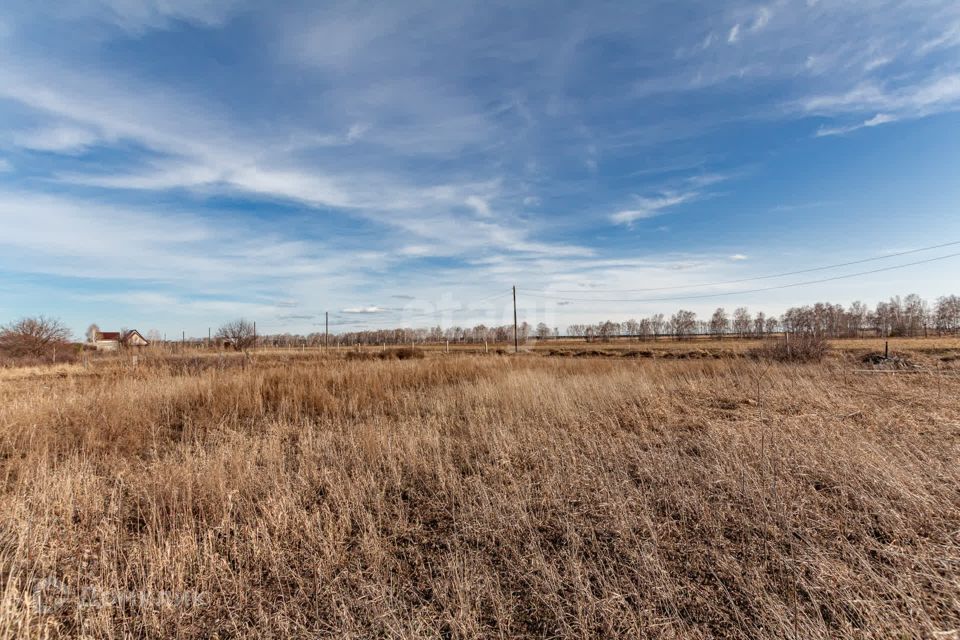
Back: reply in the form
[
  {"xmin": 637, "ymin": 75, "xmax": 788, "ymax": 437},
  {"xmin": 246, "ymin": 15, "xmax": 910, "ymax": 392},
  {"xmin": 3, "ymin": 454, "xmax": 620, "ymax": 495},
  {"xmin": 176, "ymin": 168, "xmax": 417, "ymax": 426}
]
[{"xmin": 0, "ymin": 294, "xmax": 960, "ymax": 358}]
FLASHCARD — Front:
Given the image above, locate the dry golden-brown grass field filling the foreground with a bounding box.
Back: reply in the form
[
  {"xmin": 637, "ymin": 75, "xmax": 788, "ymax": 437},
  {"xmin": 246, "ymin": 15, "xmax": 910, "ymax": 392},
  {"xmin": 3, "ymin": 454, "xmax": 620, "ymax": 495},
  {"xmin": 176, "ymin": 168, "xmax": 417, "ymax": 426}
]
[{"xmin": 0, "ymin": 340, "xmax": 960, "ymax": 638}]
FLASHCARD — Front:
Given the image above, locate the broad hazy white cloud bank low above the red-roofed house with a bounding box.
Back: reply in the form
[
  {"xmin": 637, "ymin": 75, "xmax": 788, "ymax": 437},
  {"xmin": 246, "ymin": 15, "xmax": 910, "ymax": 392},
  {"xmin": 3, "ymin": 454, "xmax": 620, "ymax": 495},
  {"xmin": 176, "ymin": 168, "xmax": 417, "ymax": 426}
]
[{"xmin": 0, "ymin": 190, "xmax": 344, "ymax": 291}]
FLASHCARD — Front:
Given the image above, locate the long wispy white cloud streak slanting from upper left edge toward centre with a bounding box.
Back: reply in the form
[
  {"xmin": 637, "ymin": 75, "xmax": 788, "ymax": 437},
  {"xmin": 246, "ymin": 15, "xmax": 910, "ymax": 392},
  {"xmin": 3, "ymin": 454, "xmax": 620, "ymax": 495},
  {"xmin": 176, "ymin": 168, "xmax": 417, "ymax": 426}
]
[{"xmin": 0, "ymin": 57, "xmax": 589, "ymax": 262}]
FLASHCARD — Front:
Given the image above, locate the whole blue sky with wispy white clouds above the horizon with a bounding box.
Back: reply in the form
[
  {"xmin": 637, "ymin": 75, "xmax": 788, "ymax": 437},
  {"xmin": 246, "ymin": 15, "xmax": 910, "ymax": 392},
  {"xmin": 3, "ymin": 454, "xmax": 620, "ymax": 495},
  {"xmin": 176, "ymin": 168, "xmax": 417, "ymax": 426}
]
[{"xmin": 0, "ymin": 0, "xmax": 960, "ymax": 336}]
